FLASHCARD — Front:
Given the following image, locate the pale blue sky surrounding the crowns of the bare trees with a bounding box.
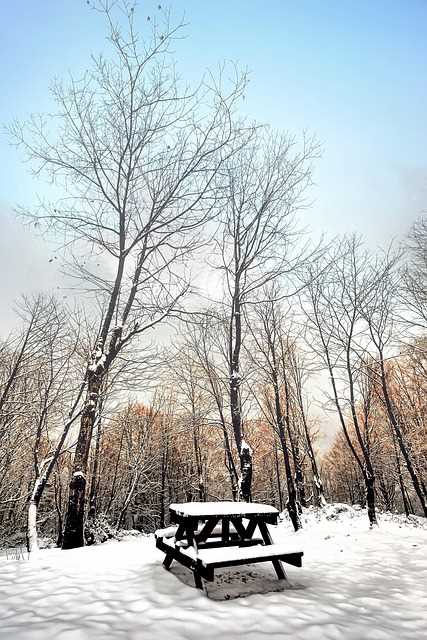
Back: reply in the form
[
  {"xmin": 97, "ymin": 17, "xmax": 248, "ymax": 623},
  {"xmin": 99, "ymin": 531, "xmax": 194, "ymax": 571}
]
[{"xmin": 0, "ymin": 0, "xmax": 427, "ymax": 320}]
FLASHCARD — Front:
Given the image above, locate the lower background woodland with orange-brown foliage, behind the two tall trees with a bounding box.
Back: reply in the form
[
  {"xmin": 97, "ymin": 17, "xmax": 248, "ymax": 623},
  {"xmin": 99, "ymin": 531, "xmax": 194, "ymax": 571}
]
[{"xmin": 0, "ymin": 223, "xmax": 427, "ymax": 544}]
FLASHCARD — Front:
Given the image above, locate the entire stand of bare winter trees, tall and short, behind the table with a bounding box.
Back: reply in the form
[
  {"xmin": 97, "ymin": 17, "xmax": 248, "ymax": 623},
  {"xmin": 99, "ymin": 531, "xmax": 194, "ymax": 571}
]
[{"xmin": 0, "ymin": 3, "xmax": 427, "ymax": 551}]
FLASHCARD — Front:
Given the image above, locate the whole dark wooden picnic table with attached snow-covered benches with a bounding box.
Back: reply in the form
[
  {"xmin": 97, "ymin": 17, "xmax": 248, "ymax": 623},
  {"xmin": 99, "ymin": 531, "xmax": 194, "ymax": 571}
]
[{"xmin": 155, "ymin": 502, "xmax": 303, "ymax": 589}]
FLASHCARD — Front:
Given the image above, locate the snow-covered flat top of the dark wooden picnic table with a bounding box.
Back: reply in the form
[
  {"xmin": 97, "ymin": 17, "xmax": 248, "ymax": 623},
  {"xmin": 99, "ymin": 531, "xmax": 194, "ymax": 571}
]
[{"xmin": 169, "ymin": 500, "xmax": 279, "ymax": 518}]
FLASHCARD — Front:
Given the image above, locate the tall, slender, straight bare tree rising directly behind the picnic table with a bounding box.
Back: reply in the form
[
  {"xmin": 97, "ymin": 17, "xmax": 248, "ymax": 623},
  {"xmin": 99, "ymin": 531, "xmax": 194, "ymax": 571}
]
[{"xmin": 217, "ymin": 130, "xmax": 318, "ymax": 500}]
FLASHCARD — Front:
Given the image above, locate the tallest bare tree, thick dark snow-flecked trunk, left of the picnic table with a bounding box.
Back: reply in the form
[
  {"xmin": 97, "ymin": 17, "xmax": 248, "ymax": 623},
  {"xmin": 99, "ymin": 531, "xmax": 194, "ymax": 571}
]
[{"xmin": 11, "ymin": 3, "xmax": 245, "ymax": 549}]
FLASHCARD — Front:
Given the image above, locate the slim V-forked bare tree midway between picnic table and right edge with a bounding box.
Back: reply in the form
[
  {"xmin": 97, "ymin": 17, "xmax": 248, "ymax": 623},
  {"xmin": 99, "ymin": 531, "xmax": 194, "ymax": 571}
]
[{"xmin": 305, "ymin": 236, "xmax": 378, "ymax": 525}]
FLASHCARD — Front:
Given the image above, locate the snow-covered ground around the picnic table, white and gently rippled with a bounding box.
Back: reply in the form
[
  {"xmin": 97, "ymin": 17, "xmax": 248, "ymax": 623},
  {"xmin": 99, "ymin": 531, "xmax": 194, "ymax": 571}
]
[{"xmin": 0, "ymin": 506, "xmax": 427, "ymax": 640}]
